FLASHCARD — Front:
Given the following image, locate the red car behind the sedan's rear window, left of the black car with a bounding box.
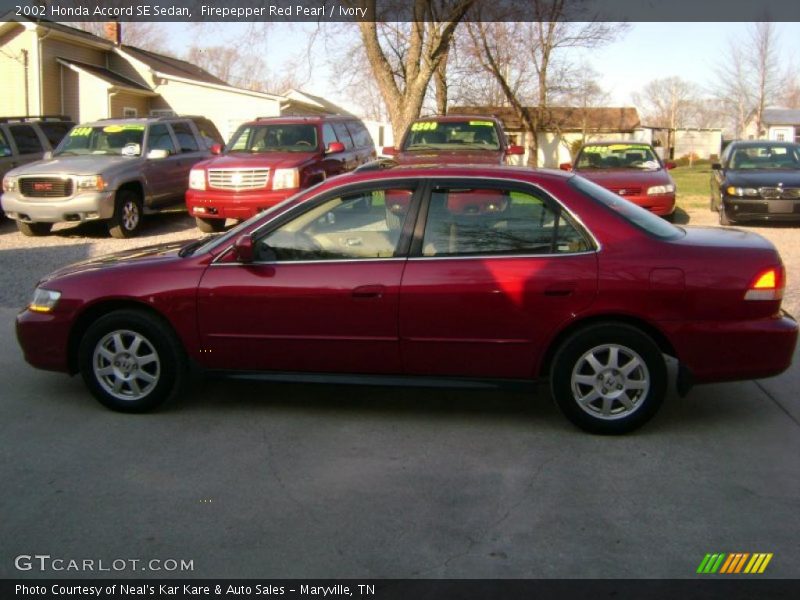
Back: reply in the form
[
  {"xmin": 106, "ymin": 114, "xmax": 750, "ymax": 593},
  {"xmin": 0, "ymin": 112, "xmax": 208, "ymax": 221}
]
[{"xmin": 560, "ymin": 141, "xmax": 675, "ymax": 220}]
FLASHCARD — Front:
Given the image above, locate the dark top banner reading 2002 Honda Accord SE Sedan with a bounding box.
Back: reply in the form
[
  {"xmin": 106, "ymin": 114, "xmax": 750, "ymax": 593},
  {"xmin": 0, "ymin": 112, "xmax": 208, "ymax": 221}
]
[{"xmin": 0, "ymin": 0, "xmax": 800, "ymax": 23}]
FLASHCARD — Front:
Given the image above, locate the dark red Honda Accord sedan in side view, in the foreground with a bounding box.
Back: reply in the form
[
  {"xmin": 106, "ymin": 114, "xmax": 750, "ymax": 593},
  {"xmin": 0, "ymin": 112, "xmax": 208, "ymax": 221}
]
[{"xmin": 17, "ymin": 166, "xmax": 798, "ymax": 433}]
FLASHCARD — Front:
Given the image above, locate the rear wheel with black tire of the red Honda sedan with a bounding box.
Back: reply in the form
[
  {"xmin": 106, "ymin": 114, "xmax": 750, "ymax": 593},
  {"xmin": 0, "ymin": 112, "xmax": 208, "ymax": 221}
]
[{"xmin": 550, "ymin": 323, "xmax": 667, "ymax": 435}]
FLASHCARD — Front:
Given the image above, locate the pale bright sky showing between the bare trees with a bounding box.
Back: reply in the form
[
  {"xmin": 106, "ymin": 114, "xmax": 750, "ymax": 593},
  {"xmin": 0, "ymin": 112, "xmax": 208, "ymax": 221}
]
[{"xmin": 159, "ymin": 21, "xmax": 800, "ymax": 109}]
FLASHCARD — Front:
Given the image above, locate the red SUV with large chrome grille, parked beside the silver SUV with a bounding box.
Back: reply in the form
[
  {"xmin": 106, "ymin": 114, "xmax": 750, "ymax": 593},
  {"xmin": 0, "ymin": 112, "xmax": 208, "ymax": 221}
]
[{"xmin": 186, "ymin": 116, "xmax": 376, "ymax": 232}]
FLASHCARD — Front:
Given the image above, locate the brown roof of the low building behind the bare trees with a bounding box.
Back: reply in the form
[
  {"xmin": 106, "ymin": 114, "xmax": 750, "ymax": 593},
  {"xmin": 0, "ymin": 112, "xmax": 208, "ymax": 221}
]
[{"xmin": 448, "ymin": 106, "xmax": 641, "ymax": 132}]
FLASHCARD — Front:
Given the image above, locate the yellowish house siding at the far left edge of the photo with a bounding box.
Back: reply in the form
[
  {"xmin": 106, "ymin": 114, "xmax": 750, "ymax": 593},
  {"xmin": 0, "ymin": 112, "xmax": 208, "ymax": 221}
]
[{"xmin": 0, "ymin": 26, "xmax": 39, "ymax": 116}]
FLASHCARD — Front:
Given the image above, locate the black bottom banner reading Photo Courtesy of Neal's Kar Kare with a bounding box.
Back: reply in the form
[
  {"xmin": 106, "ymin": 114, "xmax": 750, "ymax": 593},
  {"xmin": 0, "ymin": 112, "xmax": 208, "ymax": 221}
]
[{"xmin": 0, "ymin": 575, "xmax": 800, "ymax": 600}]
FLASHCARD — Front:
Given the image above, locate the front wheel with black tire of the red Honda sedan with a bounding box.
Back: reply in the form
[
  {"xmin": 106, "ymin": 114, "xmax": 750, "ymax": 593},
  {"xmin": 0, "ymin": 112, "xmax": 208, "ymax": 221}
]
[{"xmin": 78, "ymin": 310, "xmax": 187, "ymax": 413}]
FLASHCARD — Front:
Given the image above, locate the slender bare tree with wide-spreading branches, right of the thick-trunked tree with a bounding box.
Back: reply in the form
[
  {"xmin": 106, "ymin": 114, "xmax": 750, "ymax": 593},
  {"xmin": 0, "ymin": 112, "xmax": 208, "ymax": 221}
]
[{"xmin": 467, "ymin": 0, "xmax": 627, "ymax": 166}]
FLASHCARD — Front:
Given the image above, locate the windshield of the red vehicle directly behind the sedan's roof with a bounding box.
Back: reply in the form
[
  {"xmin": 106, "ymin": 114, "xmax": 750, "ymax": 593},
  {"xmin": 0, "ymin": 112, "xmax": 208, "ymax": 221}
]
[{"xmin": 403, "ymin": 119, "xmax": 500, "ymax": 152}]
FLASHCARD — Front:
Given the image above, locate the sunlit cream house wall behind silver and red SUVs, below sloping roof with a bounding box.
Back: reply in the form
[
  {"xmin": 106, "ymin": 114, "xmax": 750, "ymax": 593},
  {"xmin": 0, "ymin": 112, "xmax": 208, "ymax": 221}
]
[{"xmin": 155, "ymin": 79, "xmax": 280, "ymax": 140}]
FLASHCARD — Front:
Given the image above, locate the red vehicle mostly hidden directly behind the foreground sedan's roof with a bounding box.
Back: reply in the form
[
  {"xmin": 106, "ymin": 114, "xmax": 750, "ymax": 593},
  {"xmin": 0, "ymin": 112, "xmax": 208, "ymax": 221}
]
[{"xmin": 383, "ymin": 115, "xmax": 525, "ymax": 165}]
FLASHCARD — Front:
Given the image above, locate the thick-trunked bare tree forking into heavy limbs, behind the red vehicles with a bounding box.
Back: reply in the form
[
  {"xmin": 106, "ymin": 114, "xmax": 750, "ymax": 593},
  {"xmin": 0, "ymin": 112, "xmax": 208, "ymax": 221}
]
[{"xmin": 352, "ymin": 0, "xmax": 475, "ymax": 136}]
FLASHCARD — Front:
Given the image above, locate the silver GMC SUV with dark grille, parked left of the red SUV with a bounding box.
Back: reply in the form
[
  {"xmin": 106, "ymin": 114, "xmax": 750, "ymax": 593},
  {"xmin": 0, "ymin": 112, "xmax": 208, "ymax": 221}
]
[{"xmin": 2, "ymin": 117, "xmax": 221, "ymax": 238}]
